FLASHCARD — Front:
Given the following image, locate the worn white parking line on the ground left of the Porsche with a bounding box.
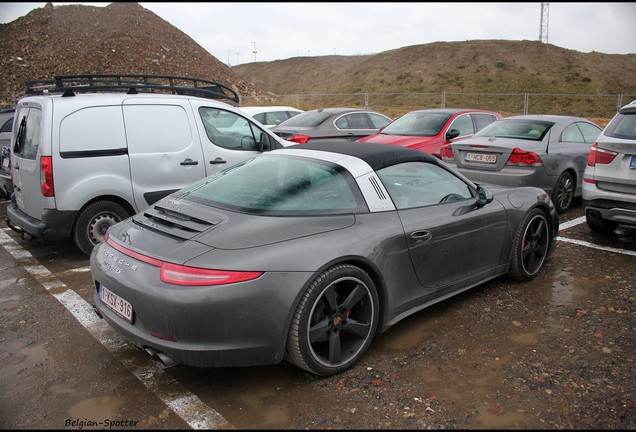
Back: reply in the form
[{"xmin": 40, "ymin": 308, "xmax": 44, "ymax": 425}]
[{"xmin": 0, "ymin": 230, "xmax": 233, "ymax": 429}]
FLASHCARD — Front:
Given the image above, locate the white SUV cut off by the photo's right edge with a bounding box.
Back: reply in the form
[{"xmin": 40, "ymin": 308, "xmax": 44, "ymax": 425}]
[{"xmin": 582, "ymin": 100, "xmax": 636, "ymax": 234}]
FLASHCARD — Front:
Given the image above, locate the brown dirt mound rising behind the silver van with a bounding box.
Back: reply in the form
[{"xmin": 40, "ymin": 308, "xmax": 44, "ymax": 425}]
[{"xmin": 0, "ymin": 3, "xmax": 259, "ymax": 107}]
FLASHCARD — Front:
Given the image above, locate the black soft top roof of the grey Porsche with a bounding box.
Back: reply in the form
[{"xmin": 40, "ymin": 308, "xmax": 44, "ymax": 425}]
[{"xmin": 287, "ymin": 140, "xmax": 439, "ymax": 171}]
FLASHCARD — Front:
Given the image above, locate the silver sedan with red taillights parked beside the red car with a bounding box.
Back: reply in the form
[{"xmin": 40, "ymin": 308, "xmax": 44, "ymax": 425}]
[{"xmin": 442, "ymin": 115, "xmax": 602, "ymax": 213}]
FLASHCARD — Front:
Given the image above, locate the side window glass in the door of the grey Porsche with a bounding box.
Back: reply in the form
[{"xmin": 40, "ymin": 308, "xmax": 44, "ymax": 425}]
[{"xmin": 378, "ymin": 162, "xmax": 473, "ymax": 210}]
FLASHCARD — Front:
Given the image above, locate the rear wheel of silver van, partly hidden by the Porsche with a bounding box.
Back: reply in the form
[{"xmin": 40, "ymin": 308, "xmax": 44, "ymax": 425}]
[{"xmin": 73, "ymin": 201, "xmax": 129, "ymax": 255}]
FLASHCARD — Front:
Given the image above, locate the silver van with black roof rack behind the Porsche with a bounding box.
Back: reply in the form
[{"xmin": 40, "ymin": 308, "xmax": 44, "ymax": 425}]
[{"xmin": 7, "ymin": 75, "xmax": 291, "ymax": 254}]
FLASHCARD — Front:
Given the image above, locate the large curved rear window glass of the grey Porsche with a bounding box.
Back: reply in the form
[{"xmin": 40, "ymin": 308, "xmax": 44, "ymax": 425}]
[{"xmin": 178, "ymin": 155, "xmax": 367, "ymax": 215}]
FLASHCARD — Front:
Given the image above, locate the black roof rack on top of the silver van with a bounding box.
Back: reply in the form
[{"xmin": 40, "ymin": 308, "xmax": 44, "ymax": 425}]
[{"xmin": 26, "ymin": 74, "xmax": 241, "ymax": 104}]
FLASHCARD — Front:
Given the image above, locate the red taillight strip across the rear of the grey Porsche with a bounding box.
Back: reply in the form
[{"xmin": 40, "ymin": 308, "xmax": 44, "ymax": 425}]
[{"xmin": 104, "ymin": 236, "xmax": 263, "ymax": 286}]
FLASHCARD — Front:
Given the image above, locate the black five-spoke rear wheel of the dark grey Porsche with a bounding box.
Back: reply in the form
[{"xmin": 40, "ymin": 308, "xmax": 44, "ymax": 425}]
[{"xmin": 285, "ymin": 265, "xmax": 379, "ymax": 376}]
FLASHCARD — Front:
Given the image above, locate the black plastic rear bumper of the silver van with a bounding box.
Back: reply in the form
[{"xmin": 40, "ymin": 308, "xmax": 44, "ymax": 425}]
[{"xmin": 7, "ymin": 195, "xmax": 77, "ymax": 241}]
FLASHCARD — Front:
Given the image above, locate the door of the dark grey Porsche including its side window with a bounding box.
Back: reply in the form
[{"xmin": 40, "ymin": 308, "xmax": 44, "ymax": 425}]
[{"xmin": 378, "ymin": 162, "xmax": 507, "ymax": 291}]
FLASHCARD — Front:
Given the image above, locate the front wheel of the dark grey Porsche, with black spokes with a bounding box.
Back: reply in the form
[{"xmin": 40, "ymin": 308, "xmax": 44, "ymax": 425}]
[{"xmin": 508, "ymin": 208, "xmax": 550, "ymax": 281}]
